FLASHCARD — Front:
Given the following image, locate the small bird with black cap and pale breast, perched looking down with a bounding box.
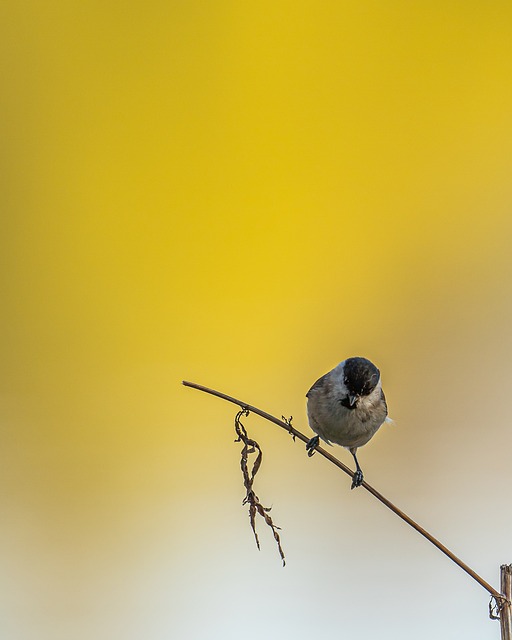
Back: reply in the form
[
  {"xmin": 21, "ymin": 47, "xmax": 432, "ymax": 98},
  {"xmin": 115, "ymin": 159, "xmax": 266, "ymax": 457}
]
[{"xmin": 306, "ymin": 358, "xmax": 391, "ymax": 489}]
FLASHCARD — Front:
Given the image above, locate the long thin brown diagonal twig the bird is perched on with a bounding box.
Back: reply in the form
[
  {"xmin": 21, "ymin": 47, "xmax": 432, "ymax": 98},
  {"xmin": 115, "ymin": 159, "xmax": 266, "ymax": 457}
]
[{"xmin": 183, "ymin": 380, "xmax": 504, "ymax": 603}]
